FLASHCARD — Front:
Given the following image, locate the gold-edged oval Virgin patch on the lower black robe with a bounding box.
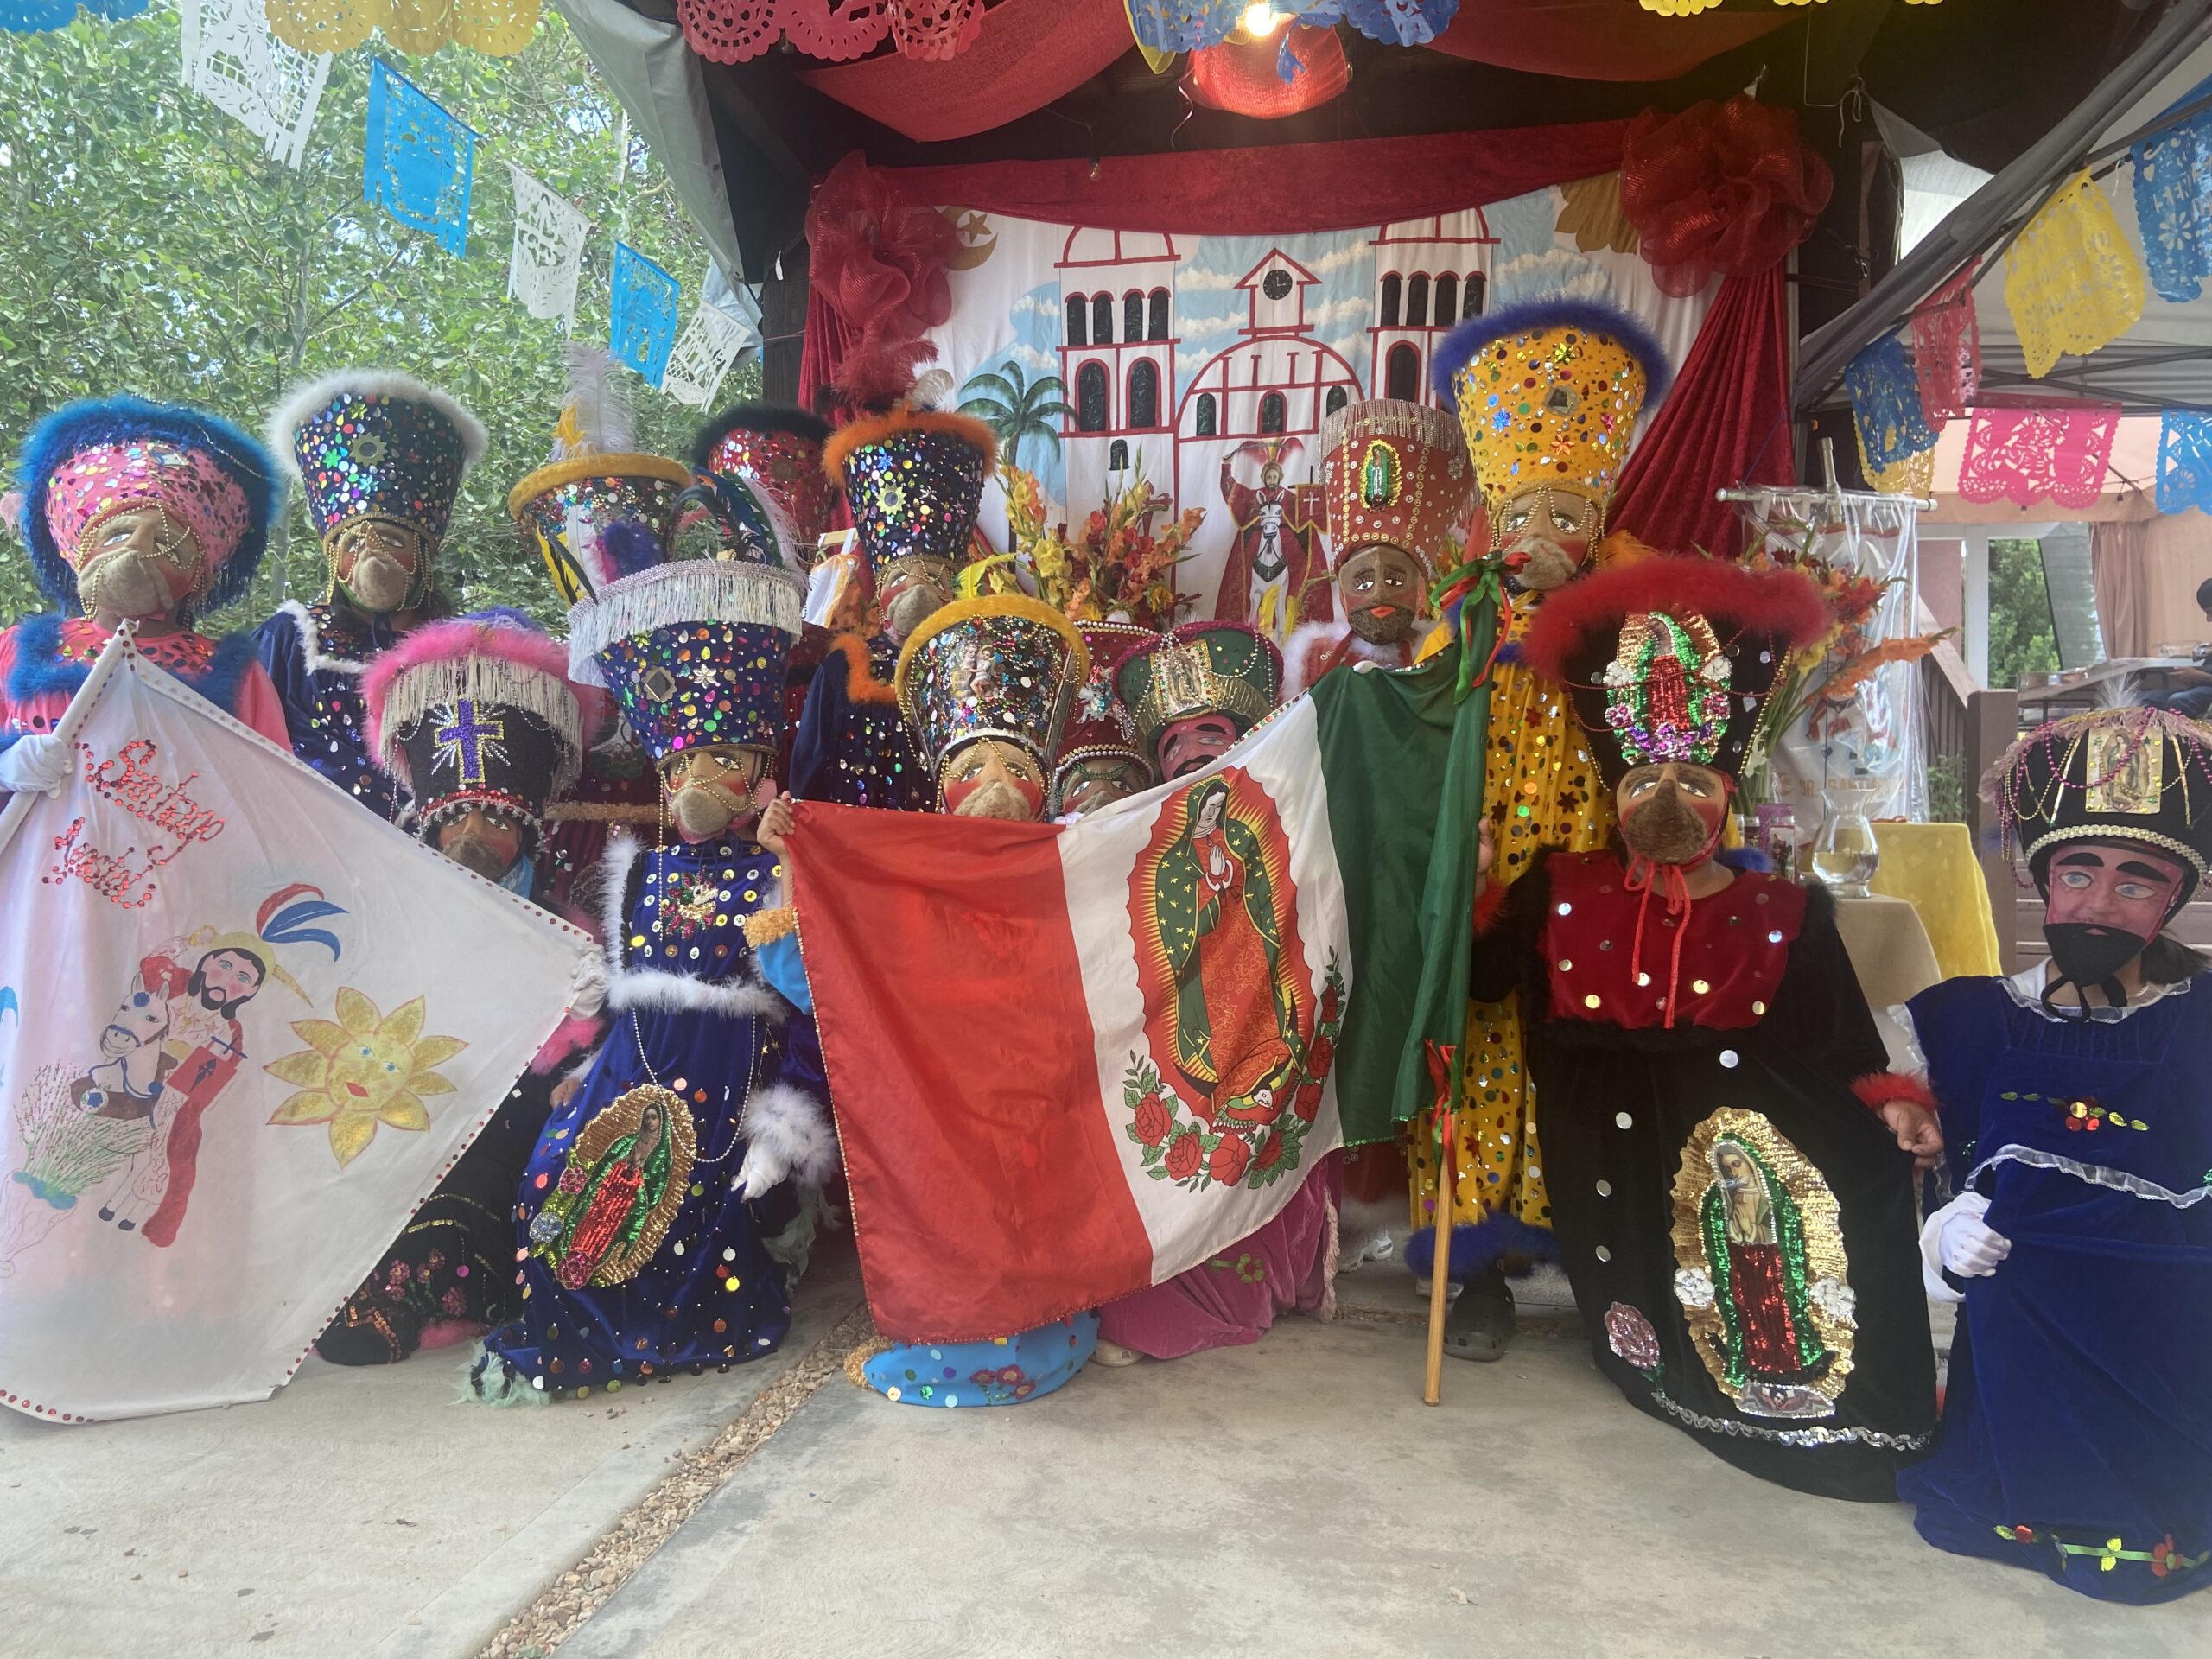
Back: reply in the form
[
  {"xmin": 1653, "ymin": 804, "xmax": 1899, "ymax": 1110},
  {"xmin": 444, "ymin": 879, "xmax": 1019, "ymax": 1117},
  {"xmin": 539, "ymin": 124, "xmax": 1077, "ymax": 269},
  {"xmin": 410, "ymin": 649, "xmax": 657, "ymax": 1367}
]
[{"xmin": 1675, "ymin": 1106, "xmax": 1858, "ymax": 1421}]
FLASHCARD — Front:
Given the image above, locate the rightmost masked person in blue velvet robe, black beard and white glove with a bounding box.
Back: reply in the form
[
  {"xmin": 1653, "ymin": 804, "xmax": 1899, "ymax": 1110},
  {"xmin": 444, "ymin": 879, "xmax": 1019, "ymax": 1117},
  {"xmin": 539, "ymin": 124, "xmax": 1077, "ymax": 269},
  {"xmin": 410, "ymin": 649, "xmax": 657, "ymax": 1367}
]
[{"xmin": 1897, "ymin": 708, "xmax": 2212, "ymax": 1601}]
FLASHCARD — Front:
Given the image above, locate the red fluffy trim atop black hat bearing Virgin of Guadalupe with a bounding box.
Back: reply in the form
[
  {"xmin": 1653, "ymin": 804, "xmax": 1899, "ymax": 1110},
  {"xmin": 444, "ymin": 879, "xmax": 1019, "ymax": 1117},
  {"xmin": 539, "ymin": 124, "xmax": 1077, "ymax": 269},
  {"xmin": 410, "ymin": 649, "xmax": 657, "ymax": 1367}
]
[{"xmin": 1522, "ymin": 557, "xmax": 1829, "ymax": 683}]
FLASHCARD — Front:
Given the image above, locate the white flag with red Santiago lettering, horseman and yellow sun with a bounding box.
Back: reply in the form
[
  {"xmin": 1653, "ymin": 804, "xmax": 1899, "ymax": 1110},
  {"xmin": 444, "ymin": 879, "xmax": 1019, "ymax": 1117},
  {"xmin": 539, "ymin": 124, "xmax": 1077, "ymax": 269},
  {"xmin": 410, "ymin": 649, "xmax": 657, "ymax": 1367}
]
[{"xmin": 0, "ymin": 631, "xmax": 588, "ymax": 1422}]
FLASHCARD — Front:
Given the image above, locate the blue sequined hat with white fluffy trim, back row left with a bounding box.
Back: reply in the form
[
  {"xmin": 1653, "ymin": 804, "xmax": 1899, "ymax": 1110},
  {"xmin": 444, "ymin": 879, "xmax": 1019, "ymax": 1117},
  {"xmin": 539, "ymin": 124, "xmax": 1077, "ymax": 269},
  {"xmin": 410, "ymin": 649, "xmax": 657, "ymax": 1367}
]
[{"xmin": 268, "ymin": 372, "xmax": 489, "ymax": 542}]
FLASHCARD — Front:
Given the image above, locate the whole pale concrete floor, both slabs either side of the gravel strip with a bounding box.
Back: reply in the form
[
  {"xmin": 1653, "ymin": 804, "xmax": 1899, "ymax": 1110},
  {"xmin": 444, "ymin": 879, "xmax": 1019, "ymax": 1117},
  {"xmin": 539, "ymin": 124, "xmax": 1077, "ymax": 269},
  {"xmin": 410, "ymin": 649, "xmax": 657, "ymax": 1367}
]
[{"xmin": 0, "ymin": 1256, "xmax": 2177, "ymax": 1659}]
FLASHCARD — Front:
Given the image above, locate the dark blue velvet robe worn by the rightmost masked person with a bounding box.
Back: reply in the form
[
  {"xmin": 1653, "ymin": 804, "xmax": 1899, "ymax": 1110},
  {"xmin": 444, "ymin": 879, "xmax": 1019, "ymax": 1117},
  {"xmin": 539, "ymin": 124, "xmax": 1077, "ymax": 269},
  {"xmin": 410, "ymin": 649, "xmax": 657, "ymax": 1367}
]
[{"xmin": 1897, "ymin": 969, "xmax": 2212, "ymax": 1601}]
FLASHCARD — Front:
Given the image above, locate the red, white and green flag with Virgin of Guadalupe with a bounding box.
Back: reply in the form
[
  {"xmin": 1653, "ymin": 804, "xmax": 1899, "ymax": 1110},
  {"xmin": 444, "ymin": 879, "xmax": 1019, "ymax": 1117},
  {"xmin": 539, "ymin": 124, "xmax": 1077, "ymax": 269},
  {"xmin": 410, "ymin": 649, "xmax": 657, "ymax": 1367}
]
[{"xmin": 791, "ymin": 652, "xmax": 1480, "ymax": 1343}]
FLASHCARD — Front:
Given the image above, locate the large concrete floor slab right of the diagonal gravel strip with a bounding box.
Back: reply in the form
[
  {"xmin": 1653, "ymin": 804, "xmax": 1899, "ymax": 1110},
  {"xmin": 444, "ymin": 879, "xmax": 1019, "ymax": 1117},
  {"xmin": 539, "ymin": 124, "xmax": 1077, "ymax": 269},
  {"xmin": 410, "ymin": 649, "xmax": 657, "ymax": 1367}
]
[{"xmin": 560, "ymin": 1282, "xmax": 2212, "ymax": 1659}]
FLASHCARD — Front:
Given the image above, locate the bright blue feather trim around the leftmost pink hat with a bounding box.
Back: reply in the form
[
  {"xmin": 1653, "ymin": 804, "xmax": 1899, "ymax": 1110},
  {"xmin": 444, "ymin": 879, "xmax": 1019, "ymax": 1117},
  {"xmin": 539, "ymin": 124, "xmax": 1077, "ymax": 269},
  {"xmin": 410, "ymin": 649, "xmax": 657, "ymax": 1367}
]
[{"xmin": 16, "ymin": 396, "xmax": 285, "ymax": 615}]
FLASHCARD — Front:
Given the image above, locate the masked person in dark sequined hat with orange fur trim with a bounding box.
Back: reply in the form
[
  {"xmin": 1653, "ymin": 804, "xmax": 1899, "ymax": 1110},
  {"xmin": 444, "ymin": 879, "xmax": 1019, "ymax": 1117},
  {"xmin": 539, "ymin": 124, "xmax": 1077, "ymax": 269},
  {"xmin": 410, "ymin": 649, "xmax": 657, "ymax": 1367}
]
[{"xmin": 790, "ymin": 404, "xmax": 998, "ymax": 812}]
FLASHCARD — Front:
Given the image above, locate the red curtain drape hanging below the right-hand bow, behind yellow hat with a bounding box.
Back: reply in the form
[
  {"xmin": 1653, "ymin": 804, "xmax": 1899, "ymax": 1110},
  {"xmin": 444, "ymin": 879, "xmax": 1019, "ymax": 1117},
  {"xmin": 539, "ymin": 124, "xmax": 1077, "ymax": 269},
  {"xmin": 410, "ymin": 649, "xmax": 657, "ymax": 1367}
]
[{"xmin": 1608, "ymin": 264, "xmax": 1796, "ymax": 556}]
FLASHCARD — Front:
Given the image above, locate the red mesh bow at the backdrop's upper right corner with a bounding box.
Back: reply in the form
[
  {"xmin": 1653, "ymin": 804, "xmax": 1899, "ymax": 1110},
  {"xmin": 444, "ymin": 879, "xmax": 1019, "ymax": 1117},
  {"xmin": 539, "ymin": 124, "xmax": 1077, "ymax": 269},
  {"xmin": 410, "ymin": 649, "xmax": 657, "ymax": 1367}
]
[{"xmin": 1621, "ymin": 93, "xmax": 1836, "ymax": 296}]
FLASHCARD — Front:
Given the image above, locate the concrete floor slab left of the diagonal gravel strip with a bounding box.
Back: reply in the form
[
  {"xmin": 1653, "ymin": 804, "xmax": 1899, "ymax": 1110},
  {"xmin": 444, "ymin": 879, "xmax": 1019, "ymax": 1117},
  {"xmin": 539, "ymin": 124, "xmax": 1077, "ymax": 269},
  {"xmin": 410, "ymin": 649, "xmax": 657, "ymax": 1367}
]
[{"xmin": 0, "ymin": 1255, "xmax": 861, "ymax": 1659}]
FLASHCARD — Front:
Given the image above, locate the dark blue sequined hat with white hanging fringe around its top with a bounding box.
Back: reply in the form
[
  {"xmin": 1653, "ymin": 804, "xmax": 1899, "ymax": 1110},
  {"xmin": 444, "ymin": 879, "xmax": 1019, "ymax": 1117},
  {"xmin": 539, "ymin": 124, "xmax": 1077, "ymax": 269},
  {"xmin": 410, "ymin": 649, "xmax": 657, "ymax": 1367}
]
[{"xmin": 569, "ymin": 478, "xmax": 805, "ymax": 761}]
